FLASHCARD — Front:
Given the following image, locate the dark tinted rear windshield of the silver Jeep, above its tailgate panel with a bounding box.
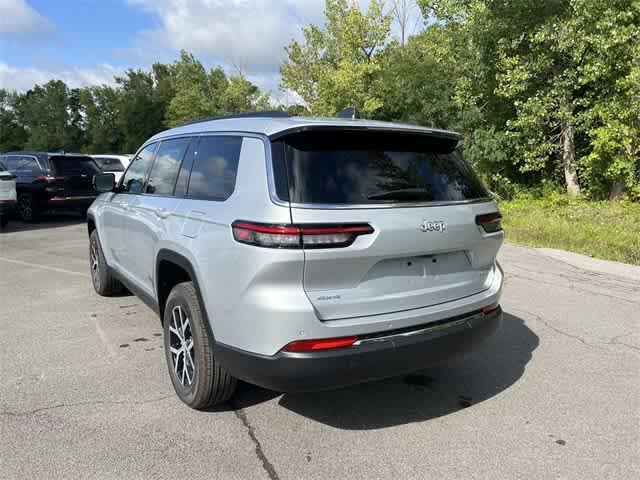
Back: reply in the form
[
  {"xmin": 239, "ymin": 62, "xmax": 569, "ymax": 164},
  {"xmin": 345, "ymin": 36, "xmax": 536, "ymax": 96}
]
[{"xmin": 272, "ymin": 130, "xmax": 489, "ymax": 205}]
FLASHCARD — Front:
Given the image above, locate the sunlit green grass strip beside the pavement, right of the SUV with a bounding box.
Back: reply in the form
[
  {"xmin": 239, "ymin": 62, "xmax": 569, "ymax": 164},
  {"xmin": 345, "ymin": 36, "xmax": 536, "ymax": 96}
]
[{"xmin": 500, "ymin": 194, "xmax": 640, "ymax": 265}]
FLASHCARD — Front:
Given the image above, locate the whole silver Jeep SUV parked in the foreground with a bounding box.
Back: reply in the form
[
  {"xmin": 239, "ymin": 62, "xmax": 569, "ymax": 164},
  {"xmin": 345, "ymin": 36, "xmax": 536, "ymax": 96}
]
[{"xmin": 88, "ymin": 113, "xmax": 504, "ymax": 408}]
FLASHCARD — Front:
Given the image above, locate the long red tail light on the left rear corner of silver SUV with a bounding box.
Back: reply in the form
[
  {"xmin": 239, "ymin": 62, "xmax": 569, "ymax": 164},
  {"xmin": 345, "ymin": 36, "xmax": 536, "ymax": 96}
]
[{"xmin": 231, "ymin": 220, "xmax": 373, "ymax": 248}]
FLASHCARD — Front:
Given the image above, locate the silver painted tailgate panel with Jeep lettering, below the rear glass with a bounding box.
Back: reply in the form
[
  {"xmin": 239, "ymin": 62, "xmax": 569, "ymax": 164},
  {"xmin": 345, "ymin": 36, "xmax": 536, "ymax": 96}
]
[{"xmin": 291, "ymin": 203, "xmax": 503, "ymax": 320}]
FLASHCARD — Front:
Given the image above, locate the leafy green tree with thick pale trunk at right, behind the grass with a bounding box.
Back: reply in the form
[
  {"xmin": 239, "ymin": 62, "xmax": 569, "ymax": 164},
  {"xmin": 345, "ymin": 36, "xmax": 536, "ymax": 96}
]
[{"xmin": 494, "ymin": 0, "xmax": 640, "ymax": 195}]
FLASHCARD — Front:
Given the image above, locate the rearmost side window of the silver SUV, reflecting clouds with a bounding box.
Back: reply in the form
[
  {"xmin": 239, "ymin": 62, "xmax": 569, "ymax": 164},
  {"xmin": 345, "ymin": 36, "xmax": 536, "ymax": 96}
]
[{"xmin": 187, "ymin": 136, "xmax": 242, "ymax": 200}]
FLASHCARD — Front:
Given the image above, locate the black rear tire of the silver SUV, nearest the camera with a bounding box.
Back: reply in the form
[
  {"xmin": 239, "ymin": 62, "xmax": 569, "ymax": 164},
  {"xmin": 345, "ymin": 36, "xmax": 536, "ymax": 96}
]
[{"xmin": 164, "ymin": 282, "xmax": 237, "ymax": 409}]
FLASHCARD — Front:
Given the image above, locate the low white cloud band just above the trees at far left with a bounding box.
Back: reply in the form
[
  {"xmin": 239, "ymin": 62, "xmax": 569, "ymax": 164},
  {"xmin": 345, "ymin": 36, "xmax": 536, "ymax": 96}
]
[{"xmin": 0, "ymin": 62, "xmax": 124, "ymax": 91}]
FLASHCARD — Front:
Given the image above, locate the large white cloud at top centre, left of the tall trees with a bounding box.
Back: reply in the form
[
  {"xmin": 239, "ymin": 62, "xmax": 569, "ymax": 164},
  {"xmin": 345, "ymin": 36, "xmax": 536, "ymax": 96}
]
[{"xmin": 129, "ymin": 0, "xmax": 324, "ymax": 74}]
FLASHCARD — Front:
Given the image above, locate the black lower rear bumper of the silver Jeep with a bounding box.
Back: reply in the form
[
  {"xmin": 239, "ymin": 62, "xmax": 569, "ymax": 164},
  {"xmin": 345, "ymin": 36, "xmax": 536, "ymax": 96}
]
[{"xmin": 215, "ymin": 308, "xmax": 502, "ymax": 392}]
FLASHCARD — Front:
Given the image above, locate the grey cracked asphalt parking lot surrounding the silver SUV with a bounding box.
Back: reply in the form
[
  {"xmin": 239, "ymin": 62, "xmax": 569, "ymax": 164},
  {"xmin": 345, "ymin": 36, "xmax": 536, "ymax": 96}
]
[{"xmin": 0, "ymin": 216, "xmax": 640, "ymax": 480}]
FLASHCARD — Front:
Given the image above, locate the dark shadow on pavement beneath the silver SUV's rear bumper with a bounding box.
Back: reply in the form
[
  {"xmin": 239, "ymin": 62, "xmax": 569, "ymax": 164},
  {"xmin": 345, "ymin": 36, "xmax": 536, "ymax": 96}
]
[{"xmin": 233, "ymin": 313, "xmax": 539, "ymax": 430}]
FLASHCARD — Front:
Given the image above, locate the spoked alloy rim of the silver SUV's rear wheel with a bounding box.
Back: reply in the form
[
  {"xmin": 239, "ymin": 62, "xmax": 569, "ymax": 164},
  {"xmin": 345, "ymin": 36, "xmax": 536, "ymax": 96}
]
[{"xmin": 169, "ymin": 305, "xmax": 195, "ymax": 387}]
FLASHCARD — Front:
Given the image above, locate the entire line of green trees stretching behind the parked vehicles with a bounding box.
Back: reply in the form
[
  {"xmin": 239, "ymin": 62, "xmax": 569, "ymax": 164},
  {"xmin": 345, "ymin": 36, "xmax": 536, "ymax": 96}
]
[{"xmin": 0, "ymin": 0, "xmax": 640, "ymax": 200}]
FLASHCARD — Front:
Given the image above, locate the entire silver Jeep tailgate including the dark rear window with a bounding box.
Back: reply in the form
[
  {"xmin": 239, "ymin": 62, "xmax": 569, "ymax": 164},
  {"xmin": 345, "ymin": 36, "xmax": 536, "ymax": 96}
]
[{"xmin": 272, "ymin": 128, "xmax": 503, "ymax": 320}]
